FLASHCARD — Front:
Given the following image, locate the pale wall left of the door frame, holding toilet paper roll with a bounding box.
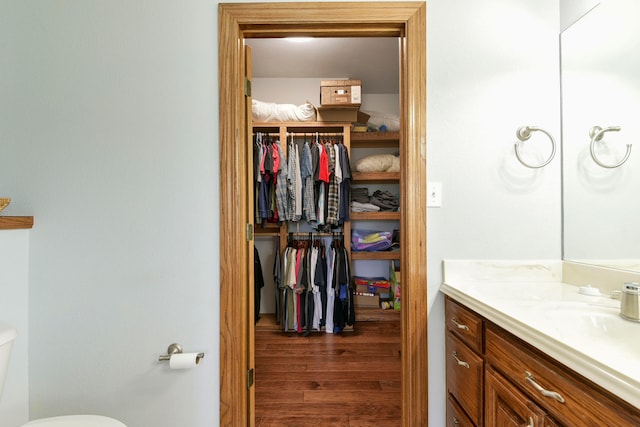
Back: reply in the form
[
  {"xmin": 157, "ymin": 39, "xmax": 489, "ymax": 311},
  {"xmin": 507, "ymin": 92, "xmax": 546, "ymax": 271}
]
[{"xmin": 0, "ymin": 0, "xmax": 219, "ymax": 427}]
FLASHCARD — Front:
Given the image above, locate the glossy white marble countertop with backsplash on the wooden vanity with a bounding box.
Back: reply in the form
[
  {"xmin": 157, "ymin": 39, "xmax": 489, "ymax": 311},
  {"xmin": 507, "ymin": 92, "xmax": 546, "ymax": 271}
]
[{"xmin": 440, "ymin": 260, "xmax": 640, "ymax": 409}]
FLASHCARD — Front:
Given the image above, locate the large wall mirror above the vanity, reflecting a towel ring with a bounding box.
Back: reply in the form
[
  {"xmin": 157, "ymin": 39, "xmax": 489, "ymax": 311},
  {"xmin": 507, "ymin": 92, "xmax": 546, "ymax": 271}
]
[{"xmin": 561, "ymin": 0, "xmax": 640, "ymax": 271}]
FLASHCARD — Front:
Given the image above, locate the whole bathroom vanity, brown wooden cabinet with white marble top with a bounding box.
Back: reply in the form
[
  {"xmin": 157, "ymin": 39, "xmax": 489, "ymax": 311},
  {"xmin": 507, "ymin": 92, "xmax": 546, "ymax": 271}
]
[{"xmin": 441, "ymin": 261, "xmax": 640, "ymax": 427}]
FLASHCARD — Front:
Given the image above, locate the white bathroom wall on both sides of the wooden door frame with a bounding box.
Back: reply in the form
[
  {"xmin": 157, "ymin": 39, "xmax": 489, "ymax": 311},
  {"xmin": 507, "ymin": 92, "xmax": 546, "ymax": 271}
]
[{"xmin": 0, "ymin": 0, "xmax": 560, "ymax": 427}]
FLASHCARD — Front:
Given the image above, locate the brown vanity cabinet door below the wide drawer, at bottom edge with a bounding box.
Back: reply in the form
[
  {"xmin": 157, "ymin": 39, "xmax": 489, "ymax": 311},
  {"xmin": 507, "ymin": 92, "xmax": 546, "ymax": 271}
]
[{"xmin": 485, "ymin": 366, "xmax": 545, "ymax": 427}]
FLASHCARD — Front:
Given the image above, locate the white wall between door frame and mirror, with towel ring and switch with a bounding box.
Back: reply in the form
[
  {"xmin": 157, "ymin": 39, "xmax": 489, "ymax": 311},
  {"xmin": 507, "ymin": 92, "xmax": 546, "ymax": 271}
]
[{"xmin": 427, "ymin": 0, "xmax": 561, "ymax": 426}]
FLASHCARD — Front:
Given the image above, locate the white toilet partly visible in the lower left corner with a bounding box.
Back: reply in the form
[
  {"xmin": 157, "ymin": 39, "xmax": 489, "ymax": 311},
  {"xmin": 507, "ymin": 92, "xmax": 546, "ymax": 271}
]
[{"xmin": 0, "ymin": 322, "xmax": 127, "ymax": 427}]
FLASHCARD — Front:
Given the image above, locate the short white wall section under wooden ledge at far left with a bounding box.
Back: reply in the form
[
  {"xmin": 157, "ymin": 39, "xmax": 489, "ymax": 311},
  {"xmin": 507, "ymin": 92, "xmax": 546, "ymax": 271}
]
[{"xmin": 0, "ymin": 230, "xmax": 29, "ymax": 427}]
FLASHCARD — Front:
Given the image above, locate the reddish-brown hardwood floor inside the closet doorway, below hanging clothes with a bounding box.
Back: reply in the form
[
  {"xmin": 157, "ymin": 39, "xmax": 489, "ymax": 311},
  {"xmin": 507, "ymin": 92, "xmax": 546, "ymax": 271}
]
[{"xmin": 255, "ymin": 309, "xmax": 402, "ymax": 427}]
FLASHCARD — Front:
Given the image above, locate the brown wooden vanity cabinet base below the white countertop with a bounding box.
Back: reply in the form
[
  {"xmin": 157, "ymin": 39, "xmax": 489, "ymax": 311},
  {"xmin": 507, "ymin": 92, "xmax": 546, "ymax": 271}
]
[{"xmin": 445, "ymin": 297, "xmax": 640, "ymax": 427}]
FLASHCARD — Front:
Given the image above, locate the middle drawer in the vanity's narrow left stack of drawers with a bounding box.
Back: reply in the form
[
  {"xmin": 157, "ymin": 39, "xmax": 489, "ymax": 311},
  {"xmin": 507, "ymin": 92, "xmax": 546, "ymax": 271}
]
[{"xmin": 446, "ymin": 332, "xmax": 484, "ymax": 425}]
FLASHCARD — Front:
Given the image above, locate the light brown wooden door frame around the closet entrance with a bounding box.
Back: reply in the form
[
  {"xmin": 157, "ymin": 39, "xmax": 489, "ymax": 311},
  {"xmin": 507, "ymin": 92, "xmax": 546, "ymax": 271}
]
[{"xmin": 218, "ymin": 2, "xmax": 428, "ymax": 427}]
